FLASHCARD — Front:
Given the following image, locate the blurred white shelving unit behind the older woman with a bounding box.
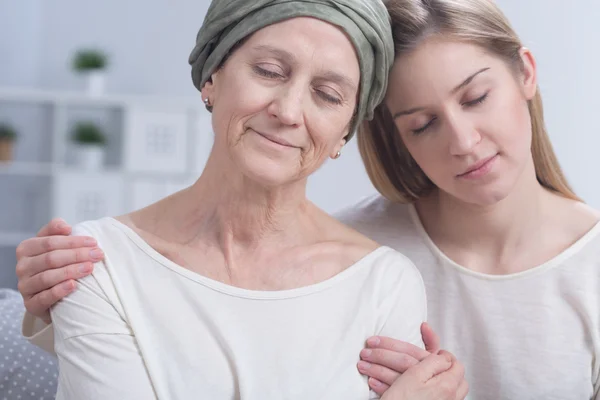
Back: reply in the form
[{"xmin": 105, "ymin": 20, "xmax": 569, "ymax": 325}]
[{"xmin": 0, "ymin": 88, "xmax": 212, "ymax": 253}]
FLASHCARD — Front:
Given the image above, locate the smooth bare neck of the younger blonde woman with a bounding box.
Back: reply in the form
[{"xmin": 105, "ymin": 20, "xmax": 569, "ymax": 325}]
[{"xmin": 417, "ymin": 161, "xmax": 552, "ymax": 273}]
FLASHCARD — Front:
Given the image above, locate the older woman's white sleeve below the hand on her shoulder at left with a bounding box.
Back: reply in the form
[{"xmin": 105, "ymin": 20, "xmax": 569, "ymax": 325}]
[{"xmin": 51, "ymin": 223, "xmax": 156, "ymax": 400}]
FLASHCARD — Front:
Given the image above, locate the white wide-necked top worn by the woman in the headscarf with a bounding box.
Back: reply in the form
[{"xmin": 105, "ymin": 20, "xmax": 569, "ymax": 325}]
[{"xmin": 45, "ymin": 218, "xmax": 426, "ymax": 400}]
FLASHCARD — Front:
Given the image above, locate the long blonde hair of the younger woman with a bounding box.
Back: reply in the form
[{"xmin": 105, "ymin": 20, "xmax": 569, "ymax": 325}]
[{"xmin": 358, "ymin": 0, "xmax": 579, "ymax": 203}]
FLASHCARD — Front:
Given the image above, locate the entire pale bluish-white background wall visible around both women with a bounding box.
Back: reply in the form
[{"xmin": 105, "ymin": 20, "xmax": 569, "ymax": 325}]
[{"xmin": 0, "ymin": 0, "xmax": 600, "ymax": 216}]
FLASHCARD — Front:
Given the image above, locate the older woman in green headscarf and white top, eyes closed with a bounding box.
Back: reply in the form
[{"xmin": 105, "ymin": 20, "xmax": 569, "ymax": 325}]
[{"xmin": 11, "ymin": 0, "xmax": 462, "ymax": 400}]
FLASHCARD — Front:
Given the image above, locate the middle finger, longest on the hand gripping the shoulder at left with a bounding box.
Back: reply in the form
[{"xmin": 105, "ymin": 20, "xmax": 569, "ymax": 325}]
[{"xmin": 17, "ymin": 247, "xmax": 104, "ymax": 280}]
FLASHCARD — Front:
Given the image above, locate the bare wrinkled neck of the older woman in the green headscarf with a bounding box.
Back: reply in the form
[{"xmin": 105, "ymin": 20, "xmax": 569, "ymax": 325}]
[{"xmin": 162, "ymin": 148, "xmax": 316, "ymax": 254}]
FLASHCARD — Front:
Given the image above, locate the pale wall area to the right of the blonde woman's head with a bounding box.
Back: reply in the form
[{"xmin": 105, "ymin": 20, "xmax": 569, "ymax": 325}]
[{"xmin": 496, "ymin": 0, "xmax": 600, "ymax": 208}]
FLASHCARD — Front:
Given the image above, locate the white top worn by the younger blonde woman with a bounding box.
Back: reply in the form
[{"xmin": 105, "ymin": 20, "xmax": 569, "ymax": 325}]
[{"xmin": 337, "ymin": 196, "xmax": 600, "ymax": 400}]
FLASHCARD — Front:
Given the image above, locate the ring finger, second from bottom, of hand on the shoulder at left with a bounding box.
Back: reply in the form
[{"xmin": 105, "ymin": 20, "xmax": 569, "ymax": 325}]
[{"xmin": 18, "ymin": 262, "xmax": 93, "ymax": 299}]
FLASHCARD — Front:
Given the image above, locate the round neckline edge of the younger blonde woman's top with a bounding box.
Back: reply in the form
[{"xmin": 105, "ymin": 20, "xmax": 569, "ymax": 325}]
[{"xmin": 408, "ymin": 204, "xmax": 600, "ymax": 281}]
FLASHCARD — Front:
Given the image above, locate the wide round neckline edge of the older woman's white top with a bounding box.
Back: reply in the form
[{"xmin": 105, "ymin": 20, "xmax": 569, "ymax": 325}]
[{"xmin": 106, "ymin": 217, "xmax": 392, "ymax": 300}]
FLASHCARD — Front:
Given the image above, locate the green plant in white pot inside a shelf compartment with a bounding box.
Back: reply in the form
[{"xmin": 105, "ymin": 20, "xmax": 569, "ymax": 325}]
[{"xmin": 71, "ymin": 122, "xmax": 106, "ymax": 170}]
